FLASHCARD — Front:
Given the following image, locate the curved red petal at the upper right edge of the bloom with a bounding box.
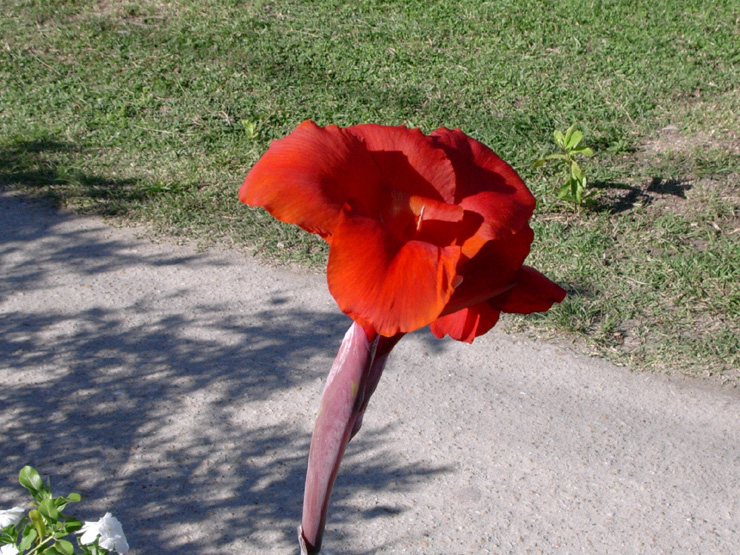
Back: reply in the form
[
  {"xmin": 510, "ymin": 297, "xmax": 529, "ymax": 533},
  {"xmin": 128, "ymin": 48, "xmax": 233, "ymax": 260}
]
[{"xmin": 431, "ymin": 127, "xmax": 536, "ymax": 257}]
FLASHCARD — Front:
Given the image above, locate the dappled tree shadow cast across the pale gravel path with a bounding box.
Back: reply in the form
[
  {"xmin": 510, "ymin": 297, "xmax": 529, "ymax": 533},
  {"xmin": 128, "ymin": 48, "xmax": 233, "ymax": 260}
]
[{"xmin": 0, "ymin": 197, "xmax": 447, "ymax": 555}]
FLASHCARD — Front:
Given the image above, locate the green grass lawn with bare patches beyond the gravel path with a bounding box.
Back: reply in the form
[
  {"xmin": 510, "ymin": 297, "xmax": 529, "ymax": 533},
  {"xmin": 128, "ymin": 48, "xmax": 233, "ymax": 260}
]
[{"xmin": 0, "ymin": 0, "xmax": 740, "ymax": 381}]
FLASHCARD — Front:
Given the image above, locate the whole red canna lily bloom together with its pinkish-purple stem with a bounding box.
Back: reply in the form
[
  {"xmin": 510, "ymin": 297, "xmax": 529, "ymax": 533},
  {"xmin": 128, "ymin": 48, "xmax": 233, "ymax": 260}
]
[{"xmin": 239, "ymin": 121, "xmax": 565, "ymax": 553}]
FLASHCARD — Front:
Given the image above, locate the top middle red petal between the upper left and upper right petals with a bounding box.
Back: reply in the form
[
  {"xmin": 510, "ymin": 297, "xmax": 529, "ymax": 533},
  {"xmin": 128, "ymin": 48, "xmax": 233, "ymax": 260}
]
[{"xmin": 346, "ymin": 123, "xmax": 455, "ymax": 203}]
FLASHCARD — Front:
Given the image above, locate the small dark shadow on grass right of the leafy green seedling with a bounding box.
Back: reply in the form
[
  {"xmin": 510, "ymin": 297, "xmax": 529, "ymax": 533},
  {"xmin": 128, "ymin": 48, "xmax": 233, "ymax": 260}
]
[{"xmin": 590, "ymin": 177, "xmax": 691, "ymax": 214}]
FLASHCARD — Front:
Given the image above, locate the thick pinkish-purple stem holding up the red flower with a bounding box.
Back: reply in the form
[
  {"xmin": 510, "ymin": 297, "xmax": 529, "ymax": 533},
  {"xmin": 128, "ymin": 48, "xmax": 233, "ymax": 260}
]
[{"xmin": 299, "ymin": 323, "xmax": 400, "ymax": 555}]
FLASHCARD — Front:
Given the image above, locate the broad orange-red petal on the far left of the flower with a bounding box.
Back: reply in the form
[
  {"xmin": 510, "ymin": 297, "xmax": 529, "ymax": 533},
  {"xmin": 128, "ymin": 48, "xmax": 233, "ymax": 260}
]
[{"xmin": 239, "ymin": 121, "xmax": 381, "ymax": 238}]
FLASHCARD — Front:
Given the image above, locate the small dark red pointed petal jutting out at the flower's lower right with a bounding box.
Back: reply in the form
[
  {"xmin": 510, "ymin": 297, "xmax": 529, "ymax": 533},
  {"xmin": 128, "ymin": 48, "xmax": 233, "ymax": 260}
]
[{"xmin": 490, "ymin": 266, "xmax": 565, "ymax": 314}]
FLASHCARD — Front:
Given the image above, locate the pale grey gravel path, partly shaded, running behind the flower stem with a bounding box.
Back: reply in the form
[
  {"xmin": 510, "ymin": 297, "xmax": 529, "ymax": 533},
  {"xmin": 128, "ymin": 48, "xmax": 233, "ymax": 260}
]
[{"xmin": 0, "ymin": 194, "xmax": 740, "ymax": 555}]
